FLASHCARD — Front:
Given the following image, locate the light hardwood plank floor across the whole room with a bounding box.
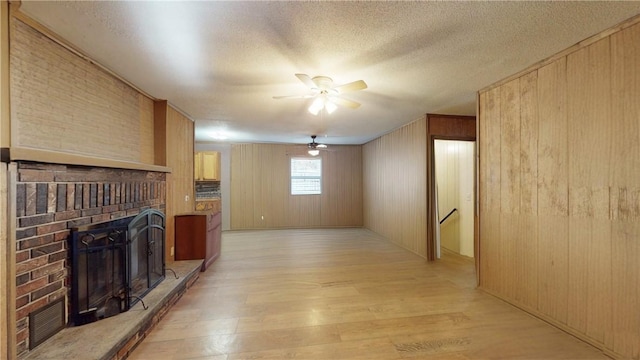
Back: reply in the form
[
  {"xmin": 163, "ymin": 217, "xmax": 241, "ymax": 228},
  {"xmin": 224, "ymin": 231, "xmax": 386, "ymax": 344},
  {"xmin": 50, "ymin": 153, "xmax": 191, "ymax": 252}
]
[{"xmin": 130, "ymin": 229, "xmax": 607, "ymax": 360}]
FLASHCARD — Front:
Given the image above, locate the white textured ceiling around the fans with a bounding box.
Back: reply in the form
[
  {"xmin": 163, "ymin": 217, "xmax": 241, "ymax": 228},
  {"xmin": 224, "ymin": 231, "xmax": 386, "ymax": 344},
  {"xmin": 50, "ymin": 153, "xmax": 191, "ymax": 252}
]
[{"xmin": 21, "ymin": 0, "xmax": 640, "ymax": 144}]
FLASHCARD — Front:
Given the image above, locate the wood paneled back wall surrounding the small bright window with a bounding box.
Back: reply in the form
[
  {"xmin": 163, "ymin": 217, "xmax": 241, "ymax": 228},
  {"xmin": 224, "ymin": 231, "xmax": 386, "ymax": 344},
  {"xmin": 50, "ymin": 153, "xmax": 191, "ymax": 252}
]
[{"xmin": 231, "ymin": 144, "xmax": 362, "ymax": 230}]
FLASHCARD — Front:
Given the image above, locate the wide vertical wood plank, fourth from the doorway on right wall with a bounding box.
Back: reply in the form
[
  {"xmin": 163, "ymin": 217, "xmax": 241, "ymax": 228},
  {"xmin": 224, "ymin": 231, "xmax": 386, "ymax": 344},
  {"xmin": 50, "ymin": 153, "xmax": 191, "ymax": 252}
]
[{"xmin": 538, "ymin": 58, "xmax": 569, "ymax": 324}]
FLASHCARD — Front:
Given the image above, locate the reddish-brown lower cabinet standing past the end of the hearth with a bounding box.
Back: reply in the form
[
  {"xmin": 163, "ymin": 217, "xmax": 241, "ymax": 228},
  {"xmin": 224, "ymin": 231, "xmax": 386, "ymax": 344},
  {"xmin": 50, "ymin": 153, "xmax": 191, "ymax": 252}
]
[{"xmin": 175, "ymin": 212, "xmax": 222, "ymax": 271}]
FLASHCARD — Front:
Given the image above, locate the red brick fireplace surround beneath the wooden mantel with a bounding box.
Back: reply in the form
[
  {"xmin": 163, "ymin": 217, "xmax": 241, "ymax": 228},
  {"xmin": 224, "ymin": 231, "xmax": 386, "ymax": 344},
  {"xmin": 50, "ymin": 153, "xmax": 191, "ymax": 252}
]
[{"xmin": 16, "ymin": 162, "xmax": 166, "ymax": 354}]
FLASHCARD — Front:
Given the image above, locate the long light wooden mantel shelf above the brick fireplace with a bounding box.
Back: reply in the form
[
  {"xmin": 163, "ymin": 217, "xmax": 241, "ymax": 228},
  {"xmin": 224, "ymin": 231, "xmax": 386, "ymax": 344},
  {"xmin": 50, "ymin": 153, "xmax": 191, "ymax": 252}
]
[{"xmin": 2, "ymin": 147, "xmax": 171, "ymax": 173}]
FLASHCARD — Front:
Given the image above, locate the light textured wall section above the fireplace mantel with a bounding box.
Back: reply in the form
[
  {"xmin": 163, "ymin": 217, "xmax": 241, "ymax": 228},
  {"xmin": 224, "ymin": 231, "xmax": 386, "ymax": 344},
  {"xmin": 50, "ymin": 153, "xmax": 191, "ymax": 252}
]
[{"xmin": 10, "ymin": 17, "xmax": 154, "ymax": 164}]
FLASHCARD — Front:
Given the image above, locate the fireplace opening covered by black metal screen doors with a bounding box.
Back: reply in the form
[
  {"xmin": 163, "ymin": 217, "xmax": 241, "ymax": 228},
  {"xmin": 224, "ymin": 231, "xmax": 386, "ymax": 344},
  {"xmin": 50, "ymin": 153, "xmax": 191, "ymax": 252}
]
[{"xmin": 70, "ymin": 209, "xmax": 165, "ymax": 325}]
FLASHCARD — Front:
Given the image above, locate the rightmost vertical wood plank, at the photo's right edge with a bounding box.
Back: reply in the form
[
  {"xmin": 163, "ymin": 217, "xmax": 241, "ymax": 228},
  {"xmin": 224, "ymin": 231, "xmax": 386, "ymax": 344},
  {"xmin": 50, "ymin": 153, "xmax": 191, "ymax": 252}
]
[{"xmin": 606, "ymin": 24, "xmax": 640, "ymax": 359}]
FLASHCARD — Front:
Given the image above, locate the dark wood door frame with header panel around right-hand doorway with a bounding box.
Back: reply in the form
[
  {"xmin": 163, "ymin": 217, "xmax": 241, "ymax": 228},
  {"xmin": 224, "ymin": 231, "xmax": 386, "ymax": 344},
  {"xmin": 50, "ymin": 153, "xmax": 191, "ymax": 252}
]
[{"xmin": 426, "ymin": 114, "xmax": 478, "ymax": 262}]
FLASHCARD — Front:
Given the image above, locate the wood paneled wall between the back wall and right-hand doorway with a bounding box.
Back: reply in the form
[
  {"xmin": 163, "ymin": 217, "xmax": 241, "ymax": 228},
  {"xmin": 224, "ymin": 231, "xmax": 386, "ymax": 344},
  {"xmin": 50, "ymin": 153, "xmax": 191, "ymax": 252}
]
[{"xmin": 363, "ymin": 118, "xmax": 427, "ymax": 257}]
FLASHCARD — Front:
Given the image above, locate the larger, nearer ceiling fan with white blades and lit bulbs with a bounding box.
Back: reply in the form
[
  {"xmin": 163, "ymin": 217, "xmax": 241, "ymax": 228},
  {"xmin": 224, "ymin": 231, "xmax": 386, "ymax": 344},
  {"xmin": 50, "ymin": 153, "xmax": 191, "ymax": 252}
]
[{"xmin": 273, "ymin": 74, "xmax": 367, "ymax": 115}]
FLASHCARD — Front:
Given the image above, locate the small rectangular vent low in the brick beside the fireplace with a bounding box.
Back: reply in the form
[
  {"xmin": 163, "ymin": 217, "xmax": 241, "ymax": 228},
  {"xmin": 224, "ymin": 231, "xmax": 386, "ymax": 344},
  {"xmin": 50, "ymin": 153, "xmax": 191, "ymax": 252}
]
[{"xmin": 29, "ymin": 297, "xmax": 65, "ymax": 350}]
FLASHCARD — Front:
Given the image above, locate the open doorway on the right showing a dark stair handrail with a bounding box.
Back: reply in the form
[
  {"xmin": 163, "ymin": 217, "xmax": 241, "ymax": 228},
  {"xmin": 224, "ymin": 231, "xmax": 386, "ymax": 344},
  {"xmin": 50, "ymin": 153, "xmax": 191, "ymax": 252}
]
[{"xmin": 434, "ymin": 140, "xmax": 475, "ymax": 259}]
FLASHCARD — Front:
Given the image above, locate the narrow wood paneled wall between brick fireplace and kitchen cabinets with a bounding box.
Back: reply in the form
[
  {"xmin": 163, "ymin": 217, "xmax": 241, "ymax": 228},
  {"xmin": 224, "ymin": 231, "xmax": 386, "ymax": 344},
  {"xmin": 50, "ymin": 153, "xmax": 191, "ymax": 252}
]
[{"xmin": 162, "ymin": 105, "xmax": 195, "ymax": 260}]
